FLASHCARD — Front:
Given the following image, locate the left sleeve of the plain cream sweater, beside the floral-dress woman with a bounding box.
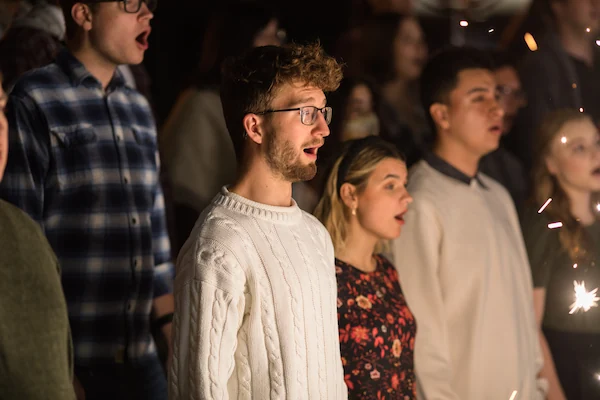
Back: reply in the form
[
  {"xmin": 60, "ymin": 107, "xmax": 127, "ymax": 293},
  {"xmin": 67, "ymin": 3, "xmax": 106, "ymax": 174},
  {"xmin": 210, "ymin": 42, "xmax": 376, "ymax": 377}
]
[{"xmin": 392, "ymin": 199, "xmax": 459, "ymax": 400}]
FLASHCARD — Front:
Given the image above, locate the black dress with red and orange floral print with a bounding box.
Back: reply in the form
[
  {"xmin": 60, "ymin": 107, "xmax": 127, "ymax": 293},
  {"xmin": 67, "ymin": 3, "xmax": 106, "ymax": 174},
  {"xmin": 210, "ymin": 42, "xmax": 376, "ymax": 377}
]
[{"xmin": 335, "ymin": 255, "xmax": 416, "ymax": 400}]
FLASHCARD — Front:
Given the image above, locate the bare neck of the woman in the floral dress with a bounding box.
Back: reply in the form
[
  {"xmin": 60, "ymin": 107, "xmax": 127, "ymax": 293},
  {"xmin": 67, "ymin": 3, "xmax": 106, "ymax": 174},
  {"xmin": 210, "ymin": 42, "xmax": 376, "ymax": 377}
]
[{"xmin": 336, "ymin": 223, "xmax": 378, "ymax": 272}]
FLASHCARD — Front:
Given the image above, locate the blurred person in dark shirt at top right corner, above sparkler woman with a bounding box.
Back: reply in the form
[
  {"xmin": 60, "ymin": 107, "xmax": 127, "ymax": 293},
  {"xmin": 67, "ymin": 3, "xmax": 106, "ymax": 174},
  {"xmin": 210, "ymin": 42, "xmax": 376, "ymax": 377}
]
[{"xmin": 515, "ymin": 0, "xmax": 600, "ymax": 171}]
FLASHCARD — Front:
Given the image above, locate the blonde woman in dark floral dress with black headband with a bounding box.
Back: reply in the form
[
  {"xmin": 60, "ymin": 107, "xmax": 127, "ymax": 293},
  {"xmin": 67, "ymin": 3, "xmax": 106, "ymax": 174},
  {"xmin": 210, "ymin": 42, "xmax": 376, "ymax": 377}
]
[{"xmin": 315, "ymin": 137, "xmax": 416, "ymax": 400}]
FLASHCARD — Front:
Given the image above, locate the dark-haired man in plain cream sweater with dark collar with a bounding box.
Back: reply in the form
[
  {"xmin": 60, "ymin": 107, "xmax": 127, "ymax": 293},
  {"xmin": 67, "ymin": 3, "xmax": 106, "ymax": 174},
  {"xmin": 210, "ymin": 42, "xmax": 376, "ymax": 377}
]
[{"xmin": 393, "ymin": 48, "xmax": 544, "ymax": 400}]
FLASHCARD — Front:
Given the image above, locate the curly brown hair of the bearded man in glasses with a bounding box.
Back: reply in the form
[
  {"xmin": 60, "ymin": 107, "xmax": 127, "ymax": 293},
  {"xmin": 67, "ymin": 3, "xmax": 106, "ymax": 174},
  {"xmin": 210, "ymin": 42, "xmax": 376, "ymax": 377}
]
[{"xmin": 221, "ymin": 42, "xmax": 342, "ymax": 161}]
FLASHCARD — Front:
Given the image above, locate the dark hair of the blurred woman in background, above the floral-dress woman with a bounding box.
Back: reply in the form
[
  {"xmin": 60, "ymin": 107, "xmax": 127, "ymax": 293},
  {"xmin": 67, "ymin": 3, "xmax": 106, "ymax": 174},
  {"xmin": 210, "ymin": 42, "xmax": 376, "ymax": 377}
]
[{"xmin": 349, "ymin": 13, "xmax": 410, "ymax": 85}]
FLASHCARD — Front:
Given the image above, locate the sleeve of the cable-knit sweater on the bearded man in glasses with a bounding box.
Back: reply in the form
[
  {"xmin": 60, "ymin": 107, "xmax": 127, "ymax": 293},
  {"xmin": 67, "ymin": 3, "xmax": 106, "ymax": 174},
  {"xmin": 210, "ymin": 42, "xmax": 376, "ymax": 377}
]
[{"xmin": 169, "ymin": 241, "xmax": 245, "ymax": 400}]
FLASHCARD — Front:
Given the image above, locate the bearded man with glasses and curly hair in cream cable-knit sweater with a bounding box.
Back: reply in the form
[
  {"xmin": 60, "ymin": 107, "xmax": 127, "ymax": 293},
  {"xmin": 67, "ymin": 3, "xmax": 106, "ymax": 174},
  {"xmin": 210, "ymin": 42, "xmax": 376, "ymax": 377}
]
[{"xmin": 169, "ymin": 45, "xmax": 347, "ymax": 400}]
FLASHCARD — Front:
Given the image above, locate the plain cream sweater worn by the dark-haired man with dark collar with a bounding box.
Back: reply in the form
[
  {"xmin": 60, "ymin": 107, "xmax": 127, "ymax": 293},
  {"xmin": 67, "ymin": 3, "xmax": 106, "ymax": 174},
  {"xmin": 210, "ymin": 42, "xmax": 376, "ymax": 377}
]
[{"xmin": 393, "ymin": 161, "xmax": 545, "ymax": 400}]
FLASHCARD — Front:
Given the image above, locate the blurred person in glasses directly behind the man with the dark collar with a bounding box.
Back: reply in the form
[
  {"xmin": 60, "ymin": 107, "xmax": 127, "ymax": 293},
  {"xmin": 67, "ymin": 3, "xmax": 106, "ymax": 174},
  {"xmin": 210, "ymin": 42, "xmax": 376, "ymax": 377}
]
[{"xmin": 479, "ymin": 51, "xmax": 528, "ymax": 210}]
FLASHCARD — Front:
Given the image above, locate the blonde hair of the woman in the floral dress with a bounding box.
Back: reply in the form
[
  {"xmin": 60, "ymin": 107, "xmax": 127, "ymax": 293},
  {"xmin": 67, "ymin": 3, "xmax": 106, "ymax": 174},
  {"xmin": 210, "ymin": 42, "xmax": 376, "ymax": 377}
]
[{"xmin": 314, "ymin": 136, "xmax": 404, "ymax": 254}]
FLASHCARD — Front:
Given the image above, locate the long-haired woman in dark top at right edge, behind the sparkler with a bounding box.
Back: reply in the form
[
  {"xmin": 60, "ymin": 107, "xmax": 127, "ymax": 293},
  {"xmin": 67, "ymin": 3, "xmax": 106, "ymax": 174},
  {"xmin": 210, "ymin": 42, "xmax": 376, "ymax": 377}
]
[{"xmin": 522, "ymin": 110, "xmax": 600, "ymax": 400}]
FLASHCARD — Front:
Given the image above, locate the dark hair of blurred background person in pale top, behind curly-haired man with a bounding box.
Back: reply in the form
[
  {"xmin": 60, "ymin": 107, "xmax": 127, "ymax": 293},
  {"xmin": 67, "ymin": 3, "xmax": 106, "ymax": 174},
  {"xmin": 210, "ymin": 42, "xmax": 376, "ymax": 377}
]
[{"xmin": 192, "ymin": 3, "xmax": 278, "ymax": 87}]
